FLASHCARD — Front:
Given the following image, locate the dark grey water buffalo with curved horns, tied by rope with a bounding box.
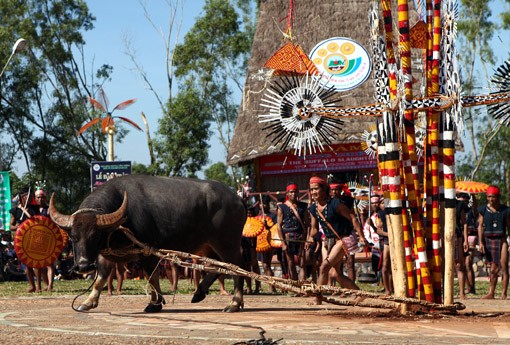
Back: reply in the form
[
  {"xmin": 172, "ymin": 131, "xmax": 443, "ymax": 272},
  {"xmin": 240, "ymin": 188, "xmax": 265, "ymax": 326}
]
[{"xmin": 49, "ymin": 175, "xmax": 246, "ymax": 312}]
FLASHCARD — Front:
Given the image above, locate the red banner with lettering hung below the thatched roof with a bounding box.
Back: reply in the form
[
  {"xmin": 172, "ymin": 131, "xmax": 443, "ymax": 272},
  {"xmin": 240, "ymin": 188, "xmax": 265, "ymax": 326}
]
[{"xmin": 260, "ymin": 143, "xmax": 377, "ymax": 175}]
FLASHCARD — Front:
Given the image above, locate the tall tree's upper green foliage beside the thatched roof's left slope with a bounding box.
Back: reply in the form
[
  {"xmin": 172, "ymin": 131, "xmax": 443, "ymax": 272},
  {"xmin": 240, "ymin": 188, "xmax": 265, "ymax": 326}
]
[{"xmin": 169, "ymin": 0, "xmax": 254, "ymax": 172}]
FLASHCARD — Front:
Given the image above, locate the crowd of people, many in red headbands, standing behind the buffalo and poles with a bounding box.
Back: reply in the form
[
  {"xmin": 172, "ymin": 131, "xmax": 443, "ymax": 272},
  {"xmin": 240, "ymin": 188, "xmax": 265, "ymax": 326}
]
[{"xmin": 0, "ymin": 176, "xmax": 510, "ymax": 304}]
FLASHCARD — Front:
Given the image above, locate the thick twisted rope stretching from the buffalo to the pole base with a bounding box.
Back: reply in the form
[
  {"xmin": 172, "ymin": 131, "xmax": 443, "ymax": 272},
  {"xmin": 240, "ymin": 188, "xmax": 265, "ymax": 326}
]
[{"xmin": 101, "ymin": 226, "xmax": 466, "ymax": 313}]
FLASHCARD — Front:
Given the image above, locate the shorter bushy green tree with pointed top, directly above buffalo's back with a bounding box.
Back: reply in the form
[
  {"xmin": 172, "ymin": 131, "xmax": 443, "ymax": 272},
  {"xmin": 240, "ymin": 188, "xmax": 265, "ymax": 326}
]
[{"xmin": 154, "ymin": 80, "xmax": 210, "ymax": 177}]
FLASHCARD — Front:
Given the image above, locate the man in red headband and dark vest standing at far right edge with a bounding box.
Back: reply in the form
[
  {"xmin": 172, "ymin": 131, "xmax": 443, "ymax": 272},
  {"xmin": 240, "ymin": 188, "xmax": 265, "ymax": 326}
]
[{"xmin": 478, "ymin": 186, "xmax": 510, "ymax": 299}]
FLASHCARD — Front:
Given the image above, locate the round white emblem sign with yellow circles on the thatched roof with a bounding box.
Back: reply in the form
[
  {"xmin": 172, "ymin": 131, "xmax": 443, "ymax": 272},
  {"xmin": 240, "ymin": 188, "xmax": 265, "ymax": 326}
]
[{"xmin": 310, "ymin": 37, "xmax": 372, "ymax": 91}]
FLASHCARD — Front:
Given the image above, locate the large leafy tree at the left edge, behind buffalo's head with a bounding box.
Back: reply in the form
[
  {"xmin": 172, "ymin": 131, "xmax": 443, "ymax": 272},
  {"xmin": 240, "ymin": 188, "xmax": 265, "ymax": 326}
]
[{"xmin": 0, "ymin": 0, "xmax": 126, "ymax": 210}]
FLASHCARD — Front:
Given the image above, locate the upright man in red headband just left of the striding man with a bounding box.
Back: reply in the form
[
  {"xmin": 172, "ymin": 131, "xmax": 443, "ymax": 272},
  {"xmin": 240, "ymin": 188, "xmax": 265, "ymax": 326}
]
[{"xmin": 277, "ymin": 182, "xmax": 309, "ymax": 280}]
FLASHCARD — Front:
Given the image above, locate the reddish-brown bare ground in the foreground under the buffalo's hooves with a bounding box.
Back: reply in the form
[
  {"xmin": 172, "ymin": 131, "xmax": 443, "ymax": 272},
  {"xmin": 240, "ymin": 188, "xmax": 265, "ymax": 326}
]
[{"xmin": 0, "ymin": 295, "xmax": 510, "ymax": 345}]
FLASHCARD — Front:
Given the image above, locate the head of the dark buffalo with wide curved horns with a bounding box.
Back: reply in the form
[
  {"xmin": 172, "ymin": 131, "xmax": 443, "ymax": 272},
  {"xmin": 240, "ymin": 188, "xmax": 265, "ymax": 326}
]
[{"xmin": 48, "ymin": 192, "xmax": 128, "ymax": 273}]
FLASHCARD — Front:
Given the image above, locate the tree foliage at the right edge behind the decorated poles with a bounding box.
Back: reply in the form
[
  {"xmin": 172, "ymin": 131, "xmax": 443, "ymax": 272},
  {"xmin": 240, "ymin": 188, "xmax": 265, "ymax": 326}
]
[{"xmin": 457, "ymin": 0, "xmax": 510, "ymax": 202}]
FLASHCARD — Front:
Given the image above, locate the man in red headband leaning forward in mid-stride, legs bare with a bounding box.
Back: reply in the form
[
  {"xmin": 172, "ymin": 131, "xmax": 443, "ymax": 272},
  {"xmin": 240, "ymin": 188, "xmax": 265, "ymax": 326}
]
[{"xmin": 306, "ymin": 176, "xmax": 366, "ymax": 304}]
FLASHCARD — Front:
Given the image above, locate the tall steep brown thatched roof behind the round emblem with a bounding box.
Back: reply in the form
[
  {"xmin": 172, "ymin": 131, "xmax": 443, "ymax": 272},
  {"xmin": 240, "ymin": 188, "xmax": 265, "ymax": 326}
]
[{"xmin": 228, "ymin": 0, "xmax": 420, "ymax": 164}]
